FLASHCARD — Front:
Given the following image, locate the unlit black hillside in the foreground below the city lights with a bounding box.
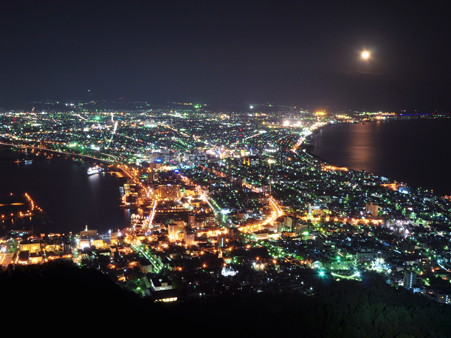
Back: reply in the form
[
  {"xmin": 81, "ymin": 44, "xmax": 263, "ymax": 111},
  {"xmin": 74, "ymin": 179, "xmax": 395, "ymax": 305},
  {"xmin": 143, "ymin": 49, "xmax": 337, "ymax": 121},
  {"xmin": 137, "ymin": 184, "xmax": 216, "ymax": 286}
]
[{"xmin": 0, "ymin": 262, "xmax": 451, "ymax": 338}]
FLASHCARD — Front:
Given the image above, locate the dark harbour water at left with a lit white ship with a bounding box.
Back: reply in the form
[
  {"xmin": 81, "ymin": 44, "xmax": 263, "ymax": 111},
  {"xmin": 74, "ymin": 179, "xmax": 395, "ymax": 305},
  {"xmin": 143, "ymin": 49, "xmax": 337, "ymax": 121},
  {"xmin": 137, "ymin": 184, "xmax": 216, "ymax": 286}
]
[{"xmin": 0, "ymin": 153, "xmax": 130, "ymax": 233}]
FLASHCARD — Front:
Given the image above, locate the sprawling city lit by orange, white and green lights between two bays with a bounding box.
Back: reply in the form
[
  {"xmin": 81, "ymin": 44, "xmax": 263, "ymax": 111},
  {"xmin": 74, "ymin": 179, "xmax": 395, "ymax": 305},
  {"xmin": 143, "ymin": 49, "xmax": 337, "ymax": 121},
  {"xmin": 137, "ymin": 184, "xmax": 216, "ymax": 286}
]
[{"xmin": 0, "ymin": 104, "xmax": 451, "ymax": 301}]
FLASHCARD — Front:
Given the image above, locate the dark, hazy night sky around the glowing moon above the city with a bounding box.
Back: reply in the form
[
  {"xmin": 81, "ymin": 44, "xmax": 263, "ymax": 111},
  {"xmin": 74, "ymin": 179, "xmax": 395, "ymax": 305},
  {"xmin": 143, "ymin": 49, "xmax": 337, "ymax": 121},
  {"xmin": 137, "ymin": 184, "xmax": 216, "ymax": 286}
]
[{"xmin": 0, "ymin": 0, "xmax": 451, "ymax": 111}]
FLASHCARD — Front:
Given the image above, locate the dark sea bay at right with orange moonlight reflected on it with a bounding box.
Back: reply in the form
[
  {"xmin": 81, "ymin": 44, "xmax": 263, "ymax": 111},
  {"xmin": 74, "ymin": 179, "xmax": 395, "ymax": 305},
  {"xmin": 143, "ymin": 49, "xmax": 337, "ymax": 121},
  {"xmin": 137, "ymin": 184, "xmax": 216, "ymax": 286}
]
[{"xmin": 309, "ymin": 119, "xmax": 451, "ymax": 195}]
